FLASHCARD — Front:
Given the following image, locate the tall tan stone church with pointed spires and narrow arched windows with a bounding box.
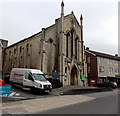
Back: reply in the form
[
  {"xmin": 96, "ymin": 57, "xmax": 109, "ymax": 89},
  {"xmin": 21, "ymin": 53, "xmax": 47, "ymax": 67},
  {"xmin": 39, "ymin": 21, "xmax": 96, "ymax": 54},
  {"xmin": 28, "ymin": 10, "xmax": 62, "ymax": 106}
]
[{"xmin": 4, "ymin": 2, "xmax": 86, "ymax": 85}]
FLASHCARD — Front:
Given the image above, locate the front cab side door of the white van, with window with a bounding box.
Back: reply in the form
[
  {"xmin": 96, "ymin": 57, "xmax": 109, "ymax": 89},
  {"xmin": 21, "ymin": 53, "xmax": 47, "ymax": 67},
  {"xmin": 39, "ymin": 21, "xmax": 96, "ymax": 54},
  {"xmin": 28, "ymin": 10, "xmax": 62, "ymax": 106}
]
[{"xmin": 23, "ymin": 72, "xmax": 34, "ymax": 87}]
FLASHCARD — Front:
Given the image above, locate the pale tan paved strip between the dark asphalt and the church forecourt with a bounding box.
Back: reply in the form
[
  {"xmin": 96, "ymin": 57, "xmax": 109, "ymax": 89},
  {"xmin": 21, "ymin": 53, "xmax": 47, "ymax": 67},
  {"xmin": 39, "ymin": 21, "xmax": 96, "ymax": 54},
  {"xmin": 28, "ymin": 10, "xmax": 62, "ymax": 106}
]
[{"xmin": 2, "ymin": 95, "xmax": 95, "ymax": 114}]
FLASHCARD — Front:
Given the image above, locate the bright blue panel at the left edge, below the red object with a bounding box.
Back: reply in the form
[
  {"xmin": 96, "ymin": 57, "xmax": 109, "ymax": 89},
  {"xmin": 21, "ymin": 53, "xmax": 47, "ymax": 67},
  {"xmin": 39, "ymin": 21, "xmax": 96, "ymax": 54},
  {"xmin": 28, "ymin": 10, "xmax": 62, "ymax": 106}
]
[{"xmin": 0, "ymin": 85, "xmax": 11, "ymax": 95}]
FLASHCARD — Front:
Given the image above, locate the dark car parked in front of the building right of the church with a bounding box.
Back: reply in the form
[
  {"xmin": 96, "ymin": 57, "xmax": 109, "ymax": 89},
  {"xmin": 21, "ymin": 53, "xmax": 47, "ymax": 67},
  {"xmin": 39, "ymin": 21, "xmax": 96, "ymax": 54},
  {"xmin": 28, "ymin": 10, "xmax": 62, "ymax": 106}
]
[{"xmin": 96, "ymin": 82, "xmax": 117, "ymax": 89}]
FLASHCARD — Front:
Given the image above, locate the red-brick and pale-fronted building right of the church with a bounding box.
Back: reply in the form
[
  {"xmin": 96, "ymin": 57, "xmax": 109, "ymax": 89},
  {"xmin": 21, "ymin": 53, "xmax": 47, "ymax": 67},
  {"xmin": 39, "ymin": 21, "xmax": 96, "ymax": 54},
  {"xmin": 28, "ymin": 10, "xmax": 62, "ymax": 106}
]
[{"xmin": 86, "ymin": 48, "xmax": 120, "ymax": 85}]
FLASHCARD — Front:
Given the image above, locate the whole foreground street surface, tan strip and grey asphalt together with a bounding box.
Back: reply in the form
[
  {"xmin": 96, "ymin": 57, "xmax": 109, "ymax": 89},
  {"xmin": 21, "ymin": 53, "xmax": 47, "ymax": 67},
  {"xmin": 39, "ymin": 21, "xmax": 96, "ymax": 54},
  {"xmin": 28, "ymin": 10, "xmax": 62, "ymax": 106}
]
[{"xmin": 2, "ymin": 89, "xmax": 119, "ymax": 114}]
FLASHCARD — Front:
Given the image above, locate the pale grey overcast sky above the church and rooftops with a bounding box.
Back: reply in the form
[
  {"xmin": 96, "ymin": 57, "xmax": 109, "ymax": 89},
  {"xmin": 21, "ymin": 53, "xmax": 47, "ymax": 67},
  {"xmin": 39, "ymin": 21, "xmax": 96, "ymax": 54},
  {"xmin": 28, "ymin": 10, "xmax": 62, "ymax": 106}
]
[{"xmin": 0, "ymin": 0, "xmax": 119, "ymax": 55}]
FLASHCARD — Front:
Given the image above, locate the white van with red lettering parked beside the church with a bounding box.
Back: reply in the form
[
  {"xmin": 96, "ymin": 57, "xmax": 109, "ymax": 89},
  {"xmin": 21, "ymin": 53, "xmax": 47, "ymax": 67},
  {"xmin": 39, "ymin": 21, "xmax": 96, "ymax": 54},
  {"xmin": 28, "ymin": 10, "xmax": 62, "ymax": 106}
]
[{"xmin": 10, "ymin": 68, "xmax": 52, "ymax": 92}]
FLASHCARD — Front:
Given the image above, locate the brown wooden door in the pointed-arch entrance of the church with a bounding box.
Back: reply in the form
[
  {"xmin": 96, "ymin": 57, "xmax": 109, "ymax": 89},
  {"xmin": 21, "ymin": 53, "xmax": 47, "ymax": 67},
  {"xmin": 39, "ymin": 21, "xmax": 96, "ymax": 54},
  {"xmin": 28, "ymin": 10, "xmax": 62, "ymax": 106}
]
[{"xmin": 70, "ymin": 67, "xmax": 78, "ymax": 85}]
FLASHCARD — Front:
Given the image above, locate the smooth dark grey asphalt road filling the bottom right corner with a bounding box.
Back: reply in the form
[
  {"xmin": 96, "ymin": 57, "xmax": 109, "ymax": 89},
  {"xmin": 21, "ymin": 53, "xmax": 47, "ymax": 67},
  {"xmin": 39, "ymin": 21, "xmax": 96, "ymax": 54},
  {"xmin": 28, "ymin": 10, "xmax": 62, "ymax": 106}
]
[{"xmin": 37, "ymin": 92, "xmax": 120, "ymax": 114}]
